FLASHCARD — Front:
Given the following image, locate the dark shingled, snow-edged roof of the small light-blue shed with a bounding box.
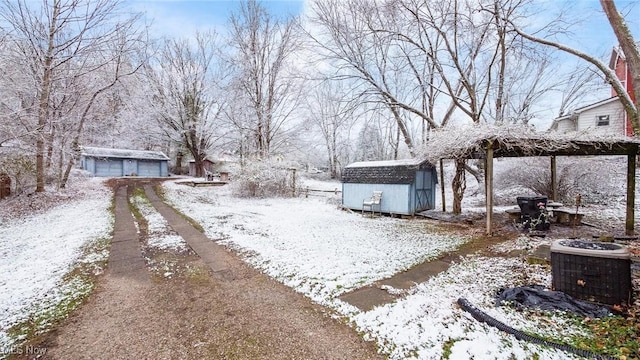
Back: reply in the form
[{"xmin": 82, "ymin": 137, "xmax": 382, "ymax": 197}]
[{"xmin": 342, "ymin": 159, "xmax": 433, "ymax": 184}]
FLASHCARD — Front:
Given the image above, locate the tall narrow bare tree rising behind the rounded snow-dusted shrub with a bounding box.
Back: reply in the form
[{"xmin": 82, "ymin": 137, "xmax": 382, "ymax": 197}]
[{"xmin": 230, "ymin": 0, "xmax": 299, "ymax": 159}]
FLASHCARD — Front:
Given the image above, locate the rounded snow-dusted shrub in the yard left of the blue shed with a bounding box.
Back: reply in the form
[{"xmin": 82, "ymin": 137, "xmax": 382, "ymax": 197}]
[{"xmin": 232, "ymin": 162, "xmax": 301, "ymax": 198}]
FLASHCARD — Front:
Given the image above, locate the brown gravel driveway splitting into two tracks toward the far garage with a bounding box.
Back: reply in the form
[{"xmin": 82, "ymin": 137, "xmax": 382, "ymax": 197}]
[{"xmin": 27, "ymin": 183, "xmax": 382, "ymax": 359}]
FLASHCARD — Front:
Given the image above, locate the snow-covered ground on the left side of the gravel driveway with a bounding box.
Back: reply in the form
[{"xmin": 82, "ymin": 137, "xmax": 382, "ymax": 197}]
[{"xmin": 0, "ymin": 179, "xmax": 113, "ymax": 344}]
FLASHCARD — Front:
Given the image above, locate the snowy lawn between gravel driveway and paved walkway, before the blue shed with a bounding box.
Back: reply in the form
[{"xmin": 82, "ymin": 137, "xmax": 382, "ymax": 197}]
[{"xmin": 165, "ymin": 183, "xmax": 468, "ymax": 306}]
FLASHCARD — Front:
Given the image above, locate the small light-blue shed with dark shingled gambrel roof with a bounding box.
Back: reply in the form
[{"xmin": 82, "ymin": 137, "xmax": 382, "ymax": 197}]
[{"xmin": 342, "ymin": 159, "xmax": 438, "ymax": 215}]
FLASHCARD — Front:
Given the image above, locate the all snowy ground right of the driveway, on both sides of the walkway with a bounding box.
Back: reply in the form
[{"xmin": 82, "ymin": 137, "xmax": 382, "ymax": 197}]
[{"xmin": 164, "ymin": 182, "xmax": 592, "ymax": 359}]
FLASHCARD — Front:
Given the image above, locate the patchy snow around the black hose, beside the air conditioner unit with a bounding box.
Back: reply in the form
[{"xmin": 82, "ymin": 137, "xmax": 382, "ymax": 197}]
[{"xmin": 352, "ymin": 257, "xmax": 577, "ymax": 359}]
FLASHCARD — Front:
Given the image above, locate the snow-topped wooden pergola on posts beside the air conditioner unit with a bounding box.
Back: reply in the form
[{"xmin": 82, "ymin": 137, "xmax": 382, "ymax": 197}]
[{"xmin": 426, "ymin": 126, "xmax": 640, "ymax": 235}]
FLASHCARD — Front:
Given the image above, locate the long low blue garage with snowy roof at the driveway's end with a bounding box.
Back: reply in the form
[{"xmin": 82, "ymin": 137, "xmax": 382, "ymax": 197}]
[{"xmin": 80, "ymin": 147, "xmax": 169, "ymax": 177}]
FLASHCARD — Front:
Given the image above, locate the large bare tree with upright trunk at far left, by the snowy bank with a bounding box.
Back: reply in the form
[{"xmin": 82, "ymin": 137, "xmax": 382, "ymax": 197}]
[{"xmin": 0, "ymin": 0, "xmax": 145, "ymax": 192}]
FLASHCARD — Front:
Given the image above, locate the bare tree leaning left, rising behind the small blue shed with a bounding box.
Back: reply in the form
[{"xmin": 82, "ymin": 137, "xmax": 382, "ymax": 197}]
[{"xmin": 308, "ymin": 0, "xmax": 438, "ymax": 156}]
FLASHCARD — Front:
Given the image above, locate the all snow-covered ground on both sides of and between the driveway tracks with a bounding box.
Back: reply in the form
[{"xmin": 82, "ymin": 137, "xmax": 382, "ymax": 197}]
[{"xmin": 0, "ymin": 173, "xmax": 632, "ymax": 359}]
